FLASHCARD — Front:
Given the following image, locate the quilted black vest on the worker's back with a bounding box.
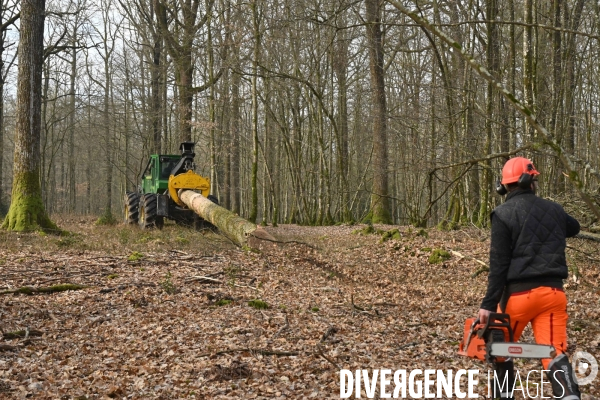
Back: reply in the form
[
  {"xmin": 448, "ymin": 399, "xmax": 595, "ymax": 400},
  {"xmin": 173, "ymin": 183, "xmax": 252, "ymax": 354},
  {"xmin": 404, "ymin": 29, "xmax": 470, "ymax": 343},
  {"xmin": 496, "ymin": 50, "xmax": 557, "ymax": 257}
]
[{"xmin": 493, "ymin": 190, "xmax": 569, "ymax": 283}]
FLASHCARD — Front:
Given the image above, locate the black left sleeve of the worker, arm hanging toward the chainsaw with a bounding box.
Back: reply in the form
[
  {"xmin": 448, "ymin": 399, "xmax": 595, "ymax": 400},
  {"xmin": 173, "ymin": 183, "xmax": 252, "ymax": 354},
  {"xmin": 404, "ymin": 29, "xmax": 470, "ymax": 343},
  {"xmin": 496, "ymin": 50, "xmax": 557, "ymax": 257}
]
[{"xmin": 481, "ymin": 213, "xmax": 512, "ymax": 312}]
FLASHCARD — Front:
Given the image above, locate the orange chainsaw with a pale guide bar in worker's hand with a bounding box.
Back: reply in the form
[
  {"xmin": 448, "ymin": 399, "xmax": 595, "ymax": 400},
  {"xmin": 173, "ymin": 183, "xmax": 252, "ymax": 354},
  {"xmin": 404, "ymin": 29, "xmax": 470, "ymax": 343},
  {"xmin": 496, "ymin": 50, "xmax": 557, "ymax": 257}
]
[{"xmin": 458, "ymin": 313, "xmax": 556, "ymax": 364}]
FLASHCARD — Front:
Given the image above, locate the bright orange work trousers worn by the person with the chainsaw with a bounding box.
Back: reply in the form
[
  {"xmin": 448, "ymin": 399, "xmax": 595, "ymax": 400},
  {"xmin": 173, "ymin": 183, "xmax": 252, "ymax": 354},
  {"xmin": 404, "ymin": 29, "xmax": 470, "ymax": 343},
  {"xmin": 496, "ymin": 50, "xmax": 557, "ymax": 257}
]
[{"xmin": 504, "ymin": 286, "xmax": 568, "ymax": 369}]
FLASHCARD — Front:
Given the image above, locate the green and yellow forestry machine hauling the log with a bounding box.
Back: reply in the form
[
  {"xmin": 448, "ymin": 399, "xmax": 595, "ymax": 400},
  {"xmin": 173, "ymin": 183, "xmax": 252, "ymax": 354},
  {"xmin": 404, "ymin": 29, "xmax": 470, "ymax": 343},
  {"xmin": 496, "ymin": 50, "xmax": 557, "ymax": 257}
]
[{"xmin": 124, "ymin": 142, "xmax": 218, "ymax": 229}]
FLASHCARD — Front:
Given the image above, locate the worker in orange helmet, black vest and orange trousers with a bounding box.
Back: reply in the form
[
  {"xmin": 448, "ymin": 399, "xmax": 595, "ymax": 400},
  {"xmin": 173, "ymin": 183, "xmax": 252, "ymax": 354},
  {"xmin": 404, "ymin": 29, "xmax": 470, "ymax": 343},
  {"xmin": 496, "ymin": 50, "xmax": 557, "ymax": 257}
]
[{"xmin": 479, "ymin": 157, "xmax": 581, "ymax": 400}]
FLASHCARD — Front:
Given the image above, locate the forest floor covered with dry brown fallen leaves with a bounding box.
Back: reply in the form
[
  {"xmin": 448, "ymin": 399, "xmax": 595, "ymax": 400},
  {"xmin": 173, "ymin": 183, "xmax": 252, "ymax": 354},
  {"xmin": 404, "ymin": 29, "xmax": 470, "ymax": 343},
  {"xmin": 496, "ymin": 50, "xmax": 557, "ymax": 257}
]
[{"xmin": 0, "ymin": 217, "xmax": 600, "ymax": 399}]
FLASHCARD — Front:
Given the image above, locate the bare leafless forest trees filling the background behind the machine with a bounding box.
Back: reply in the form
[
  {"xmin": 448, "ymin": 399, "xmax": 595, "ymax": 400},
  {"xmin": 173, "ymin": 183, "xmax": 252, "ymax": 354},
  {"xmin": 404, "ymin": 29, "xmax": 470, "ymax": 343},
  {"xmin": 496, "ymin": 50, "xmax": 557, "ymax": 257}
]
[{"xmin": 0, "ymin": 0, "xmax": 600, "ymax": 228}]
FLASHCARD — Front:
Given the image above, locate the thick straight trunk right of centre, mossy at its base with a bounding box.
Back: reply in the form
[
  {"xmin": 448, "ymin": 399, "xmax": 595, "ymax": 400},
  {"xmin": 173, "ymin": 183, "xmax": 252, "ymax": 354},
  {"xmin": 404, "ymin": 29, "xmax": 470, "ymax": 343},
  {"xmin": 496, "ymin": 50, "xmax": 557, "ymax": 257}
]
[{"xmin": 365, "ymin": 0, "xmax": 391, "ymax": 224}]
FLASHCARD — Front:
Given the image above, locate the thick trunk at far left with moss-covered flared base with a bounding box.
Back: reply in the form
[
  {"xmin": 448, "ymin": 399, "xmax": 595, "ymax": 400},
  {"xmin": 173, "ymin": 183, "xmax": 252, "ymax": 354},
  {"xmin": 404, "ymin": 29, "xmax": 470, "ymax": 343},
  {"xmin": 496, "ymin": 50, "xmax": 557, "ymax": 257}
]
[{"xmin": 2, "ymin": 0, "xmax": 57, "ymax": 231}]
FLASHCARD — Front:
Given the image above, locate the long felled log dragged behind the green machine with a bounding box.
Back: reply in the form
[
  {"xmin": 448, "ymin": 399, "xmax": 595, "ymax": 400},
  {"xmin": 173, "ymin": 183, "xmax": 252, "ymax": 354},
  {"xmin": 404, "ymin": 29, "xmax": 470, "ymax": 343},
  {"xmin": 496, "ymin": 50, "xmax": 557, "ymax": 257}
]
[{"xmin": 179, "ymin": 190, "xmax": 277, "ymax": 247}]
